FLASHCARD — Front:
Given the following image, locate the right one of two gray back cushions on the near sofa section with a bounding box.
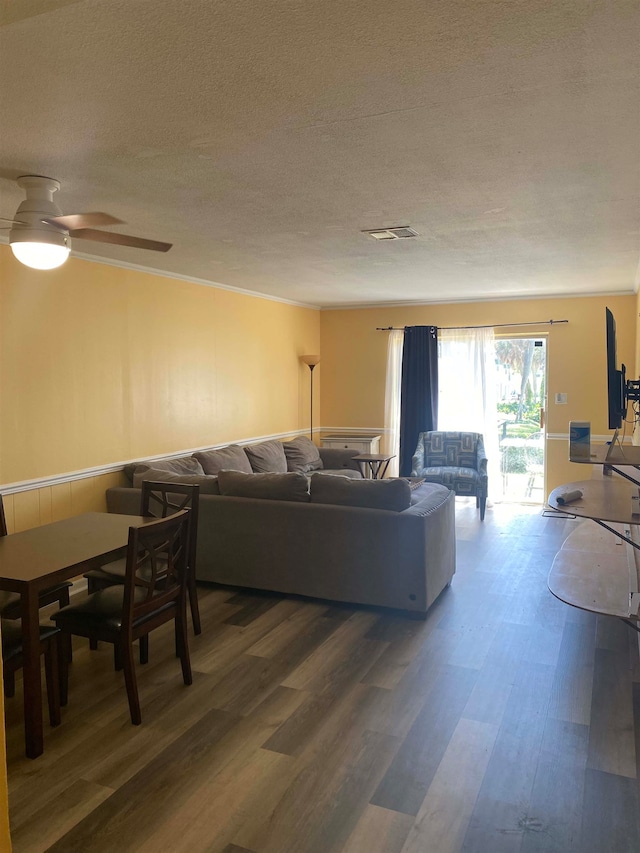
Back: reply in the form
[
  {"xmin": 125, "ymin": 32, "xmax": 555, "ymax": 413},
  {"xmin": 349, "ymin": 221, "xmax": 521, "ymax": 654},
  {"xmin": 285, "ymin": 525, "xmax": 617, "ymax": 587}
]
[{"xmin": 310, "ymin": 474, "xmax": 411, "ymax": 512}]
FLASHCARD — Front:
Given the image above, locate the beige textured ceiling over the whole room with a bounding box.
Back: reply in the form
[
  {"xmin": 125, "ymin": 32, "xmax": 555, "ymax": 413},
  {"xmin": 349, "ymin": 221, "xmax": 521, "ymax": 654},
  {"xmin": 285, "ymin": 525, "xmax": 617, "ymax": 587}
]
[{"xmin": 0, "ymin": 0, "xmax": 640, "ymax": 306}]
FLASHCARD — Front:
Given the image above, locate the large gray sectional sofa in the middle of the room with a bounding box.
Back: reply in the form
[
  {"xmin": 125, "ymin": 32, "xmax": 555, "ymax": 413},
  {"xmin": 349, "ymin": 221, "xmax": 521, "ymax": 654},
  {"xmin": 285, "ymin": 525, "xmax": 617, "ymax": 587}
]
[{"xmin": 107, "ymin": 439, "xmax": 455, "ymax": 614}]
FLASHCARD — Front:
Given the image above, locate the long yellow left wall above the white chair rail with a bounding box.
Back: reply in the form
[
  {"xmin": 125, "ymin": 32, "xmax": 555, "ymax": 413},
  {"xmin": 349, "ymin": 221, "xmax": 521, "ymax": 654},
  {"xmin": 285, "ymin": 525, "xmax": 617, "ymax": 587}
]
[{"xmin": 0, "ymin": 246, "xmax": 320, "ymax": 484}]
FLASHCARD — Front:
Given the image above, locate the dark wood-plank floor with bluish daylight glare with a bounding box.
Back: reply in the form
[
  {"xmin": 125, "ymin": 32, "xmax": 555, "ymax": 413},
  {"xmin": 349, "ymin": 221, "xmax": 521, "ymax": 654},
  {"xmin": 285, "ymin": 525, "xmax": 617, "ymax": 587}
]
[{"xmin": 6, "ymin": 502, "xmax": 640, "ymax": 853}]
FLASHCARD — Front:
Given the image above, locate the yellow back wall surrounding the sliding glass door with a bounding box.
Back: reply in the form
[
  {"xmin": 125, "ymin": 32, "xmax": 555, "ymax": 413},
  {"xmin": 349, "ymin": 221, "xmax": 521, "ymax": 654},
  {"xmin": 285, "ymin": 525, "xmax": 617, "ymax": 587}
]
[{"xmin": 321, "ymin": 296, "xmax": 637, "ymax": 489}]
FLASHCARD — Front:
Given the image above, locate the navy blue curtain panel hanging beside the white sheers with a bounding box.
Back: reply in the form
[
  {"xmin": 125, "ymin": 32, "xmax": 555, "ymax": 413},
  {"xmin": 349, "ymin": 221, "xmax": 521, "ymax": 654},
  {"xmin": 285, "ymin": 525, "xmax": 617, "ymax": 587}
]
[{"xmin": 400, "ymin": 326, "xmax": 438, "ymax": 477}]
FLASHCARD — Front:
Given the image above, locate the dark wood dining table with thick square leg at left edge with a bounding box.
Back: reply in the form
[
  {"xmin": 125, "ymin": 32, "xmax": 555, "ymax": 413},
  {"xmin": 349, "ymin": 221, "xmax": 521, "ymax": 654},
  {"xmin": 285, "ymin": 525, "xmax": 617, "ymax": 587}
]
[{"xmin": 0, "ymin": 512, "xmax": 152, "ymax": 758}]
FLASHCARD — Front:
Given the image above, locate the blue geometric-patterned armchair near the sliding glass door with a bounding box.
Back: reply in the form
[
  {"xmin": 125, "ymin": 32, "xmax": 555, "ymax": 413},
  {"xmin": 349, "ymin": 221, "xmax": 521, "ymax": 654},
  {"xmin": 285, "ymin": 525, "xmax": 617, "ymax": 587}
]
[{"xmin": 411, "ymin": 432, "xmax": 488, "ymax": 521}]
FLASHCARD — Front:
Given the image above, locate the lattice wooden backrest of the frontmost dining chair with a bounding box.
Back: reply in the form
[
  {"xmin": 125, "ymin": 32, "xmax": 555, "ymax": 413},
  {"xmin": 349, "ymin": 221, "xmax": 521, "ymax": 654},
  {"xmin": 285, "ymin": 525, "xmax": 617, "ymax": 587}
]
[{"xmin": 122, "ymin": 509, "xmax": 189, "ymax": 630}]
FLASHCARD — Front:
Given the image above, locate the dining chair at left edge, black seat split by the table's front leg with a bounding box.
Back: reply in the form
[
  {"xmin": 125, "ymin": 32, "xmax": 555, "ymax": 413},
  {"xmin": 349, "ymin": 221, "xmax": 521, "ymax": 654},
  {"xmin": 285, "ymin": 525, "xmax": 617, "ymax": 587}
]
[{"xmin": 0, "ymin": 619, "xmax": 62, "ymax": 726}]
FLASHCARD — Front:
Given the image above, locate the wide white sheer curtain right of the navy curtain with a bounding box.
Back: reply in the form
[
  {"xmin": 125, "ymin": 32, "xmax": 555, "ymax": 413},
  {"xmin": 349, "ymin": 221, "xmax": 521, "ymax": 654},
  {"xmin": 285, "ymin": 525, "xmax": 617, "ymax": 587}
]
[{"xmin": 438, "ymin": 329, "xmax": 501, "ymax": 499}]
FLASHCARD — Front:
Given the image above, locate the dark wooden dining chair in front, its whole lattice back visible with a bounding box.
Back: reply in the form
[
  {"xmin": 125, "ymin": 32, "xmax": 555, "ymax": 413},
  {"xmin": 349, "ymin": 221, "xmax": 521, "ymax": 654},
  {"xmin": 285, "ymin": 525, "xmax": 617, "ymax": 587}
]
[{"xmin": 51, "ymin": 510, "xmax": 192, "ymax": 725}]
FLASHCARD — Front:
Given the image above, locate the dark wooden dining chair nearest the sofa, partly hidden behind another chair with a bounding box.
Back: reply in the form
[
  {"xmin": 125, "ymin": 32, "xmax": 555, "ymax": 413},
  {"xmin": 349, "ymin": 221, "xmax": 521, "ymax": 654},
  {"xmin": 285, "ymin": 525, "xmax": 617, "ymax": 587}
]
[{"xmin": 85, "ymin": 480, "xmax": 202, "ymax": 632}]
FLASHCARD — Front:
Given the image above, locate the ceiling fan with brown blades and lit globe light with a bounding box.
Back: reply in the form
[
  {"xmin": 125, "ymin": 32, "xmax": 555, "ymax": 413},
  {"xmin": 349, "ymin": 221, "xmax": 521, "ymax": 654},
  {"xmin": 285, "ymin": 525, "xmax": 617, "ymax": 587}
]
[{"xmin": 4, "ymin": 175, "xmax": 172, "ymax": 270}]
